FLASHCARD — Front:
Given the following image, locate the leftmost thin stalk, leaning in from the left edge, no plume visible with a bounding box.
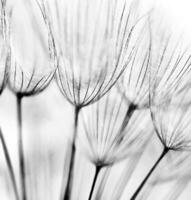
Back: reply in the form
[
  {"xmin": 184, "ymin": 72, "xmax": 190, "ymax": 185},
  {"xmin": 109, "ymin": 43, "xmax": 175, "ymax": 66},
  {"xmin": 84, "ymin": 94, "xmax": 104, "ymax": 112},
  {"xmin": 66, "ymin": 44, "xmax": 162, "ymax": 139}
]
[{"xmin": 0, "ymin": 129, "xmax": 19, "ymax": 200}]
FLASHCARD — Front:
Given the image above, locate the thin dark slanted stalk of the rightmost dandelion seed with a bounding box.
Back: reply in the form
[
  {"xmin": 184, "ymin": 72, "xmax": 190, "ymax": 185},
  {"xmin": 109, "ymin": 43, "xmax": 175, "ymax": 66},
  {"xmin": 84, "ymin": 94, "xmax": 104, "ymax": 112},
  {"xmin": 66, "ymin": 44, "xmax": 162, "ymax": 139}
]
[{"xmin": 130, "ymin": 148, "xmax": 169, "ymax": 200}]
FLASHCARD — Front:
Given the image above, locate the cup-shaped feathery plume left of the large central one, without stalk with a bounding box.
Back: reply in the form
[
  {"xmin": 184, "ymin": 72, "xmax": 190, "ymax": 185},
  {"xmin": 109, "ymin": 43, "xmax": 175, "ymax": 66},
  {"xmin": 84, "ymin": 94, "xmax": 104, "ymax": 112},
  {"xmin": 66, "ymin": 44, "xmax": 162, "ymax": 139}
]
[{"xmin": 9, "ymin": 0, "xmax": 56, "ymax": 96}]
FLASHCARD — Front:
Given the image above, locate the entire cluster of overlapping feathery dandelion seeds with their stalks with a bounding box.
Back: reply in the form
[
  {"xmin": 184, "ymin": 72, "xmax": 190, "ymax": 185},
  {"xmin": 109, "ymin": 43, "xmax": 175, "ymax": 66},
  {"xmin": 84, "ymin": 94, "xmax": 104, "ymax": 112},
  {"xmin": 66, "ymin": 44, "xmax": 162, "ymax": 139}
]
[{"xmin": 0, "ymin": 0, "xmax": 191, "ymax": 200}]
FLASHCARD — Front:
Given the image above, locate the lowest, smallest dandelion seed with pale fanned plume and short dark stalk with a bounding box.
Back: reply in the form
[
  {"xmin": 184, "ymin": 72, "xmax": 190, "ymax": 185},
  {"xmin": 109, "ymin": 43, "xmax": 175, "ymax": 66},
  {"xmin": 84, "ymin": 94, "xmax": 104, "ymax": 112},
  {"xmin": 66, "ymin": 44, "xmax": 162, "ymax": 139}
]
[{"xmin": 79, "ymin": 91, "xmax": 153, "ymax": 200}]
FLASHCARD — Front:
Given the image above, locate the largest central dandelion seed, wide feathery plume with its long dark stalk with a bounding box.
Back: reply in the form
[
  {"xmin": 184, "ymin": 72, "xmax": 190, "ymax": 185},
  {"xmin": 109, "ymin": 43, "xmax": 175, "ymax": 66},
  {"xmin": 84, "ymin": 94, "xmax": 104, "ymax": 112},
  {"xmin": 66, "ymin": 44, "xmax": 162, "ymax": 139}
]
[{"xmin": 37, "ymin": 0, "xmax": 148, "ymax": 199}]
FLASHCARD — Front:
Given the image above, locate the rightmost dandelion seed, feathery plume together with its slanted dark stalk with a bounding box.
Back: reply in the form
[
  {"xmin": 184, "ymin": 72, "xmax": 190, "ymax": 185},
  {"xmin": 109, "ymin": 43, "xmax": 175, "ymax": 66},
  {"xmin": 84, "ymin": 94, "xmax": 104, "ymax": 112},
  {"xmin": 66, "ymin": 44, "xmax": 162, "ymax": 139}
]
[{"xmin": 131, "ymin": 25, "xmax": 191, "ymax": 200}]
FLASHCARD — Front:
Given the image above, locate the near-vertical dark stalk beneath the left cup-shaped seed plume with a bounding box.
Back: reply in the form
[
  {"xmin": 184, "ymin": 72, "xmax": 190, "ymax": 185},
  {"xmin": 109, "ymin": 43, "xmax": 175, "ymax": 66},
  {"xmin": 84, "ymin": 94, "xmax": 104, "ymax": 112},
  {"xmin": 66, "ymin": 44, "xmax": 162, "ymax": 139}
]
[{"xmin": 17, "ymin": 94, "xmax": 27, "ymax": 200}]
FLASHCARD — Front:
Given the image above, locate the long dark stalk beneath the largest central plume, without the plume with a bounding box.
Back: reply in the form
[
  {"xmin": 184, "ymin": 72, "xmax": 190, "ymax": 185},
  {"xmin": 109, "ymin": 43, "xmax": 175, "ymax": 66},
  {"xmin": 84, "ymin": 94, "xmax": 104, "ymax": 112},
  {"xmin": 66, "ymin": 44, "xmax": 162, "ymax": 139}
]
[{"xmin": 63, "ymin": 106, "xmax": 80, "ymax": 200}]
